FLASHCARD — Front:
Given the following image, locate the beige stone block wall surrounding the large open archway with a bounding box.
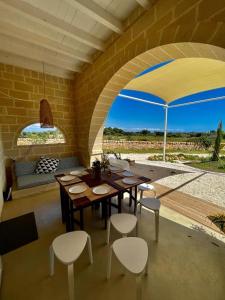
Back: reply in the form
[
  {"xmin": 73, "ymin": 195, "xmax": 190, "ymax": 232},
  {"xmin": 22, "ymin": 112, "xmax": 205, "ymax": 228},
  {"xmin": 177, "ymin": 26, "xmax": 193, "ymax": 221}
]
[{"xmin": 74, "ymin": 0, "xmax": 225, "ymax": 164}]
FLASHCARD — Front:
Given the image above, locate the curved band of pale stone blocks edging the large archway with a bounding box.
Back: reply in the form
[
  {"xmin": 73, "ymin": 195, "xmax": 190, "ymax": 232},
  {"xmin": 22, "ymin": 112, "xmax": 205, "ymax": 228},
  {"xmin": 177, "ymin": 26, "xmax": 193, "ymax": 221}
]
[{"xmin": 88, "ymin": 42, "xmax": 225, "ymax": 162}]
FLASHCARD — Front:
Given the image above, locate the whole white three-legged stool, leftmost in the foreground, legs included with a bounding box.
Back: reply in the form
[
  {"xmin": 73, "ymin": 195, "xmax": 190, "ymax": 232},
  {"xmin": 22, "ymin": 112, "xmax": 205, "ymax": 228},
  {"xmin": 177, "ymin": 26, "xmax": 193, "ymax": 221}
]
[{"xmin": 49, "ymin": 231, "xmax": 93, "ymax": 300}]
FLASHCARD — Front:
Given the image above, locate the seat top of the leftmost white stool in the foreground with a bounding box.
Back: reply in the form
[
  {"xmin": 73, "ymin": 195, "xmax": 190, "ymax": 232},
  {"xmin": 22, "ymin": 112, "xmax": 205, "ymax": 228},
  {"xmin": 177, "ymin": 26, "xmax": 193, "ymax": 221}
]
[{"xmin": 52, "ymin": 231, "xmax": 88, "ymax": 264}]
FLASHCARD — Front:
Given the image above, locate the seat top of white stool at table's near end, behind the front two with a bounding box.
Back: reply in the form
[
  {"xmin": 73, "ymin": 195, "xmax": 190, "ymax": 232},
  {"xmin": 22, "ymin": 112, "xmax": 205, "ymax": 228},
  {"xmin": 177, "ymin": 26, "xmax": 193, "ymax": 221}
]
[{"xmin": 110, "ymin": 213, "xmax": 137, "ymax": 234}]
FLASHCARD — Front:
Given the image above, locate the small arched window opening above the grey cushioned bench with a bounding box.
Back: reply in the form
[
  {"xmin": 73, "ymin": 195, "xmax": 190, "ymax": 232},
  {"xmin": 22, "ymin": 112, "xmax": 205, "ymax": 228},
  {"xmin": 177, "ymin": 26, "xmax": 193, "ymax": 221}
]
[{"xmin": 17, "ymin": 123, "xmax": 66, "ymax": 146}]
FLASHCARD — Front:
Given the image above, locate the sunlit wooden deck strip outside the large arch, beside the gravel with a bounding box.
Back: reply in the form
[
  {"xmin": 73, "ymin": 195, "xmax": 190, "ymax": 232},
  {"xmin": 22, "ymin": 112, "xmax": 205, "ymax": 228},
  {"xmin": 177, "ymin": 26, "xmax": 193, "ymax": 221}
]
[{"xmin": 145, "ymin": 183, "xmax": 225, "ymax": 233}]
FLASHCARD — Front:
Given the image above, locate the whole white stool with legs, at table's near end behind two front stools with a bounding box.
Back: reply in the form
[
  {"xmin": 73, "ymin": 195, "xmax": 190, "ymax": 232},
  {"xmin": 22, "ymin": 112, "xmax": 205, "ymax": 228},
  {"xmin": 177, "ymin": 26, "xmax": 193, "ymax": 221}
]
[{"xmin": 106, "ymin": 213, "xmax": 138, "ymax": 245}]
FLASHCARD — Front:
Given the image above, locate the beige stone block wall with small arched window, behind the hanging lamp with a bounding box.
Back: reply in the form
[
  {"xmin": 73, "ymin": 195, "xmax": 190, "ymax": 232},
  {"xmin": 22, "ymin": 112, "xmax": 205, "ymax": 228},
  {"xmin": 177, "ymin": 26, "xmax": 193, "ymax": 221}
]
[{"xmin": 0, "ymin": 64, "xmax": 76, "ymax": 160}]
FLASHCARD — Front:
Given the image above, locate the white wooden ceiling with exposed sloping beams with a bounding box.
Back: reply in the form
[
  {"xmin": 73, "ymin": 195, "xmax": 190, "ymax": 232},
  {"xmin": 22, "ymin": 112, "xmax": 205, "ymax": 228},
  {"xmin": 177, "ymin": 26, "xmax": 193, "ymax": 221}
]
[{"xmin": 0, "ymin": 0, "xmax": 147, "ymax": 77}]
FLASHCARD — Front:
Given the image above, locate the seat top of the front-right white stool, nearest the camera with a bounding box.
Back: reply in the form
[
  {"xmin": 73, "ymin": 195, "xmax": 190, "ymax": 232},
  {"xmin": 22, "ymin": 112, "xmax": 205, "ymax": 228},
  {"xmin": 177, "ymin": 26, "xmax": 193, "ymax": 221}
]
[{"xmin": 112, "ymin": 237, "xmax": 148, "ymax": 275}]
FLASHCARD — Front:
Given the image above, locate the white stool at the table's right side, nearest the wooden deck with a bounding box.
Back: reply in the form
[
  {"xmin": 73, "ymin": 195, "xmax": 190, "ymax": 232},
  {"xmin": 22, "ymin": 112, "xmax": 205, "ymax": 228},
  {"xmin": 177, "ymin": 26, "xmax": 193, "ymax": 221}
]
[{"xmin": 138, "ymin": 198, "xmax": 161, "ymax": 242}]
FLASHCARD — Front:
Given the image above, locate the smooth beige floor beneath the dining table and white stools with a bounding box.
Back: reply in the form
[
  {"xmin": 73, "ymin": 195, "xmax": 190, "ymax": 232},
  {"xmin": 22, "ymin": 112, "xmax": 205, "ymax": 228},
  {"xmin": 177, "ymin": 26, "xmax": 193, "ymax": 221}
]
[{"xmin": 1, "ymin": 190, "xmax": 225, "ymax": 300}]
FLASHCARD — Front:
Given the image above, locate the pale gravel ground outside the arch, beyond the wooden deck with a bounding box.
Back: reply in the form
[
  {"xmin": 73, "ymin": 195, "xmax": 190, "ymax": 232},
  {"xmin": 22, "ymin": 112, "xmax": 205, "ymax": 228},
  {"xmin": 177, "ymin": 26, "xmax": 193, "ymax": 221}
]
[{"xmin": 122, "ymin": 154, "xmax": 225, "ymax": 208}]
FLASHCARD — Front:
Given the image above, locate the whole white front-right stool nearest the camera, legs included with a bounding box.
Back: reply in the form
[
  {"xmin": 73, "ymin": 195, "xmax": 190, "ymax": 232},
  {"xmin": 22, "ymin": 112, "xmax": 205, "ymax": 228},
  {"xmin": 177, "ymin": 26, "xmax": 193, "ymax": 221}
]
[{"xmin": 107, "ymin": 237, "xmax": 148, "ymax": 300}]
